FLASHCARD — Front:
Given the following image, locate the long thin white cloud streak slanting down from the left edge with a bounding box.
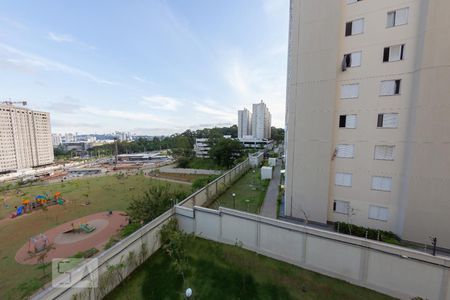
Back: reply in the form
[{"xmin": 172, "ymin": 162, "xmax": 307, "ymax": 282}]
[{"xmin": 0, "ymin": 43, "xmax": 116, "ymax": 85}]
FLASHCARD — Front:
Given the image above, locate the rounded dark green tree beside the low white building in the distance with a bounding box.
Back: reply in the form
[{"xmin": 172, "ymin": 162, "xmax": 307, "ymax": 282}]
[{"xmin": 209, "ymin": 138, "xmax": 243, "ymax": 168}]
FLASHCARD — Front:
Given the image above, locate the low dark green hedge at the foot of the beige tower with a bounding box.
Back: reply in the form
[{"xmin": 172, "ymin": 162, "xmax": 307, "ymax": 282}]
[{"xmin": 334, "ymin": 222, "xmax": 401, "ymax": 245}]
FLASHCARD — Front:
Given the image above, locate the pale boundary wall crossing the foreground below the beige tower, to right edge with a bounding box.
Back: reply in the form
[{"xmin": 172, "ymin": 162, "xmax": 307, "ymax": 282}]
[{"xmin": 175, "ymin": 206, "xmax": 450, "ymax": 300}]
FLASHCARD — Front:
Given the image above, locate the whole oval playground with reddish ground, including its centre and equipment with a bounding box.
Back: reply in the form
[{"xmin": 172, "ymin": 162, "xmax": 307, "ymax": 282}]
[{"xmin": 15, "ymin": 211, "xmax": 127, "ymax": 264}]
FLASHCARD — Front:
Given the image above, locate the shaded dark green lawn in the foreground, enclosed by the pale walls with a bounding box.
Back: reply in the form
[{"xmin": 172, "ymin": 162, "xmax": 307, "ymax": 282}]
[{"xmin": 107, "ymin": 238, "xmax": 392, "ymax": 300}]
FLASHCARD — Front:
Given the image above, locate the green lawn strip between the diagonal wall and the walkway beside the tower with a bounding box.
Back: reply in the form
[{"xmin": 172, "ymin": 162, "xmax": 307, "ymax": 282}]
[{"xmin": 210, "ymin": 169, "xmax": 269, "ymax": 213}]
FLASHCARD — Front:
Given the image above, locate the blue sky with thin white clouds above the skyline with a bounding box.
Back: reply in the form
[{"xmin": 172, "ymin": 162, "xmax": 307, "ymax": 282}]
[{"xmin": 0, "ymin": 0, "xmax": 289, "ymax": 135}]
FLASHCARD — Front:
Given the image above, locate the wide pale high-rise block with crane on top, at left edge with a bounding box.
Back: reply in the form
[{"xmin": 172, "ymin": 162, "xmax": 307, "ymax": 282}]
[{"xmin": 0, "ymin": 104, "xmax": 53, "ymax": 172}]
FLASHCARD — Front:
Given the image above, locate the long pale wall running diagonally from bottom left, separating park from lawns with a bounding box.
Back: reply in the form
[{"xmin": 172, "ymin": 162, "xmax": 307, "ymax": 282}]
[{"xmin": 32, "ymin": 160, "xmax": 249, "ymax": 299}]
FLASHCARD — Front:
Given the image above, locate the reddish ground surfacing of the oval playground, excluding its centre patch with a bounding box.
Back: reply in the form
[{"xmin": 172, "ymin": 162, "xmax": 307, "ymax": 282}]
[{"xmin": 16, "ymin": 211, "xmax": 127, "ymax": 264}]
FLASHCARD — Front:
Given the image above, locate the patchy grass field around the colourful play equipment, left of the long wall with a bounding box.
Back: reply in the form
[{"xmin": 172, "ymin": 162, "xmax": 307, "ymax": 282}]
[{"xmin": 0, "ymin": 176, "xmax": 191, "ymax": 299}]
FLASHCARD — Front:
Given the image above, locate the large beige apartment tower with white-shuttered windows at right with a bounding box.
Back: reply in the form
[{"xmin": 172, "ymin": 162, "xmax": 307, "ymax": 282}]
[{"xmin": 285, "ymin": 0, "xmax": 450, "ymax": 248}]
